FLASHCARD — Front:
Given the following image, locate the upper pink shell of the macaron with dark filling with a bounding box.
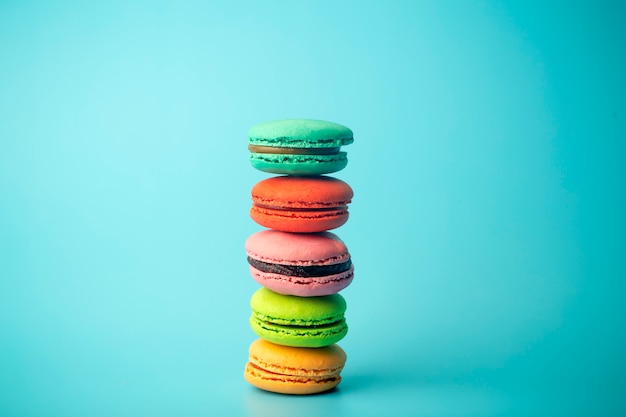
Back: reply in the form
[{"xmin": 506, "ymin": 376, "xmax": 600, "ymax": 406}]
[{"xmin": 245, "ymin": 229, "xmax": 350, "ymax": 266}]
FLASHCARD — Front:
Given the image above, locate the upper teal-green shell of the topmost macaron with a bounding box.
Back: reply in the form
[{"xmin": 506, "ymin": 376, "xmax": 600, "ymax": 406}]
[{"xmin": 248, "ymin": 119, "xmax": 354, "ymax": 148}]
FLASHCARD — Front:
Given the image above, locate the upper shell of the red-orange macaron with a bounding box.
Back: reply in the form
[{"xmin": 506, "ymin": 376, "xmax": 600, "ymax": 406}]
[{"xmin": 251, "ymin": 176, "xmax": 354, "ymax": 209}]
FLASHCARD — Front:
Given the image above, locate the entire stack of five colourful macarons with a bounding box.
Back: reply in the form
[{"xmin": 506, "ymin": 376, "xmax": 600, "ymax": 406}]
[{"xmin": 244, "ymin": 119, "xmax": 354, "ymax": 394}]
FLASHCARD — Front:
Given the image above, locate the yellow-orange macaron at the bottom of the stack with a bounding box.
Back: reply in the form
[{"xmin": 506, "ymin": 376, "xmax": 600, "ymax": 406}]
[{"xmin": 244, "ymin": 339, "xmax": 346, "ymax": 395}]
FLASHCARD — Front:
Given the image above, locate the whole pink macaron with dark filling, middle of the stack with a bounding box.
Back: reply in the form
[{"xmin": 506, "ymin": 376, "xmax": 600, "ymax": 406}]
[{"xmin": 246, "ymin": 230, "xmax": 354, "ymax": 297}]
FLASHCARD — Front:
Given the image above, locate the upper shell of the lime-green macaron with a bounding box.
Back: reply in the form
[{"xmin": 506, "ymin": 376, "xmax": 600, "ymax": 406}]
[{"xmin": 250, "ymin": 287, "xmax": 346, "ymax": 326}]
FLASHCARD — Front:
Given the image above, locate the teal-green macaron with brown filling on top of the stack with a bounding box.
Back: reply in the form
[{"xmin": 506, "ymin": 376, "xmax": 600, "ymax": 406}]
[{"xmin": 248, "ymin": 119, "xmax": 354, "ymax": 175}]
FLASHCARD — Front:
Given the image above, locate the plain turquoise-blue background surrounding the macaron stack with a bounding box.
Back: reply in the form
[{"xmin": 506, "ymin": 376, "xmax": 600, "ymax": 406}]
[{"xmin": 0, "ymin": 0, "xmax": 626, "ymax": 417}]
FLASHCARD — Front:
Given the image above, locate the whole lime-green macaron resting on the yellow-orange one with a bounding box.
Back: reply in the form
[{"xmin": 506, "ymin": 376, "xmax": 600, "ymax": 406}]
[{"xmin": 250, "ymin": 287, "xmax": 348, "ymax": 347}]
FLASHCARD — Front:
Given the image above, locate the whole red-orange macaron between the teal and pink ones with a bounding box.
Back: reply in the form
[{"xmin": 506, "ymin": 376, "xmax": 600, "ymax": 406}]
[{"xmin": 250, "ymin": 175, "xmax": 353, "ymax": 233}]
